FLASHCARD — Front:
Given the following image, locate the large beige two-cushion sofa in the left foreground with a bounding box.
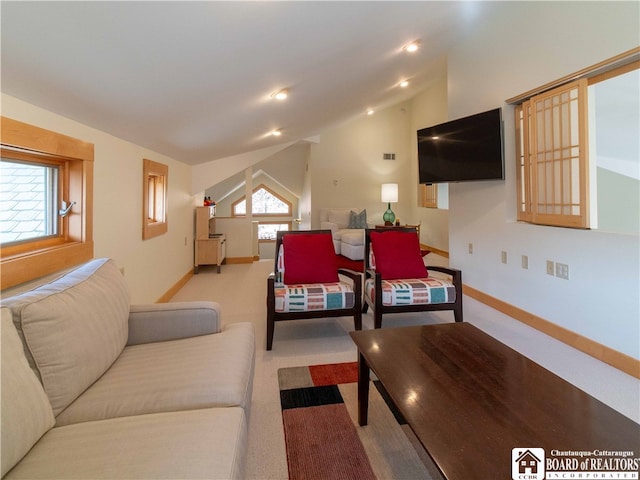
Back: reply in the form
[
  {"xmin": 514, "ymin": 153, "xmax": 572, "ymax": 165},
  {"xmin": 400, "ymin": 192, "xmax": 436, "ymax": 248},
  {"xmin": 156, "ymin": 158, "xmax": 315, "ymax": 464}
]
[{"xmin": 0, "ymin": 259, "xmax": 255, "ymax": 480}]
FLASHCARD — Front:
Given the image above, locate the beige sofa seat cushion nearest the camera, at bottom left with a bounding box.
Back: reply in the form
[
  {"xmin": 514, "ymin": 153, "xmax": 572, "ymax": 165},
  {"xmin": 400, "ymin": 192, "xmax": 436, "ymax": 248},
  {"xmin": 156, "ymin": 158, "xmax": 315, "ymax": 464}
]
[{"xmin": 3, "ymin": 407, "xmax": 247, "ymax": 480}]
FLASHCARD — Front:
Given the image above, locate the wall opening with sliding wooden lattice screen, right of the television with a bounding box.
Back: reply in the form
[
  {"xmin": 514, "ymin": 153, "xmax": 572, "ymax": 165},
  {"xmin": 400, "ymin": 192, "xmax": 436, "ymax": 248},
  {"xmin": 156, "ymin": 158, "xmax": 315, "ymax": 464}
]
[{"xmin": 507, "ymin": 48, "xmax": 640, "ymax": 233}]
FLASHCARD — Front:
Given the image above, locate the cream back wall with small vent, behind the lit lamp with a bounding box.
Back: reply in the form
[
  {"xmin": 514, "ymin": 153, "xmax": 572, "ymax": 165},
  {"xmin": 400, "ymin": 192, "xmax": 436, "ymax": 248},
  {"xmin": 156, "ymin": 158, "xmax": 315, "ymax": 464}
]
[{"xmin": 309, "ymin": 102, "xmax": 418, "ymax": 228}]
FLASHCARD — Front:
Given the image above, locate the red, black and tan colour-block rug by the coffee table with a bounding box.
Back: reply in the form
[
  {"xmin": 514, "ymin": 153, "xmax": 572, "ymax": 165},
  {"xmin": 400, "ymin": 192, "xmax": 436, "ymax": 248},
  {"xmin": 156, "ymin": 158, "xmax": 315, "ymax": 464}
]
[{"xmin": 278, "ymin": 362, "xmax": 431, "ymax": 480}]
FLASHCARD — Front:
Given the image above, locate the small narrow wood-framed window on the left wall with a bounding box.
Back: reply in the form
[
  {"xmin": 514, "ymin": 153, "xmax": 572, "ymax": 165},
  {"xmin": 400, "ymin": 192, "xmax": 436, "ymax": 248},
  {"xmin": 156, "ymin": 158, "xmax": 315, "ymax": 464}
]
[{"xmin": 142, "ymin": 158, "xmax": 169, "ymax": 240}]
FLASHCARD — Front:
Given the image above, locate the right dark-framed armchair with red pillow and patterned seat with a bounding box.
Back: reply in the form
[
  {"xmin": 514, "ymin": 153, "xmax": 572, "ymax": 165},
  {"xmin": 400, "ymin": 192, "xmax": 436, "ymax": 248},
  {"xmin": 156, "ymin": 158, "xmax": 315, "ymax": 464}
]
[{"xmin": 362, "ymin": 227, "xmax": 462, "ymax": 328}]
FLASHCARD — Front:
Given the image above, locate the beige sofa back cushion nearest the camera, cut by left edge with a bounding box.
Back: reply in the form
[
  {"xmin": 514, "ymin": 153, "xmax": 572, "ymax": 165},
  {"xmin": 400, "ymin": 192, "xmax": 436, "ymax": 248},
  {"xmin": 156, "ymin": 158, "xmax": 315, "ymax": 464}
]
[{"xmin": 0, "ymin": 308, "xmax": 55, "ymax": 477}]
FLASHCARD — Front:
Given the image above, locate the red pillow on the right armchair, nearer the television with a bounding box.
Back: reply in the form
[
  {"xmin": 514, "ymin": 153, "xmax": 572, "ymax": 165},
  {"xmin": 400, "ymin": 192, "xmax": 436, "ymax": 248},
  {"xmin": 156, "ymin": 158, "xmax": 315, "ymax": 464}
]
[{"xmin": 370, "ymin": 231, "xmax": 428, "ymax": 280}]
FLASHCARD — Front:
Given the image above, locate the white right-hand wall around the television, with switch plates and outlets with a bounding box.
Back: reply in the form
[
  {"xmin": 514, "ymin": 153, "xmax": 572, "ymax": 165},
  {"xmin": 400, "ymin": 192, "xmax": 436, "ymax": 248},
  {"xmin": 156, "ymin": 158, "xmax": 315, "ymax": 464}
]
[{"xmin": 448, "ymin": 2, "xmax": 640, "ymax": 358}]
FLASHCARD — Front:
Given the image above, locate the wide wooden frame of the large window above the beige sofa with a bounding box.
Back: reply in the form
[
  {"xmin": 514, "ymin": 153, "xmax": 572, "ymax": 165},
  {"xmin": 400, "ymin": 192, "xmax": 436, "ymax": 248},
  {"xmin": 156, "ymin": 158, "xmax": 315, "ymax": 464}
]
[{"xmin": 0, "ymin": 117, "xmax": 94, "ymax": 289}]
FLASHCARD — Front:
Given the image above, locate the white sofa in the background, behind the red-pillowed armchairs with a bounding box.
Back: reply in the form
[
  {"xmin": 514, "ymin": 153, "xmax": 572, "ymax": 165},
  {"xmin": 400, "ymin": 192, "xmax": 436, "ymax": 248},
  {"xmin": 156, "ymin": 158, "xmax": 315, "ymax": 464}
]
[{"xmin": 319, "ymin": 208, "xmax": 373, "ymax": 260}]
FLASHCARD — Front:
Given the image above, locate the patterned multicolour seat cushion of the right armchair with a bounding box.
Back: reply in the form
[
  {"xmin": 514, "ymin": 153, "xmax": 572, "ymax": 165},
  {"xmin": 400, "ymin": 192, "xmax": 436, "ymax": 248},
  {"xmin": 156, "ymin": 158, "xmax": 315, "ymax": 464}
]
[{"xmin": 364, "ymin": 277, "xmax": 456, "ymax": 306}]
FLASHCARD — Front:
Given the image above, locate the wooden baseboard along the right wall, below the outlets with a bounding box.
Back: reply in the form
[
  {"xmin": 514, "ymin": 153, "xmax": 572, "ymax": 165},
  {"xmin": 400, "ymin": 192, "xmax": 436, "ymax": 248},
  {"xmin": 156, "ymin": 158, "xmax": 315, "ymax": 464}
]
[{"xmin": 462, "ymin": 285, "xmax": 640, "ymax": 378}]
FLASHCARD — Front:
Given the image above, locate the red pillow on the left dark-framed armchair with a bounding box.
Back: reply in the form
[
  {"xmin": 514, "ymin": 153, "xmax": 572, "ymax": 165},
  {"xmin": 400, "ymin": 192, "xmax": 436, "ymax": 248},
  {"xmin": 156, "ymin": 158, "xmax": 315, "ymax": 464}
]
[{"xmin": 282, "ymin": 233, "xmax": 338, "ymax": 285}]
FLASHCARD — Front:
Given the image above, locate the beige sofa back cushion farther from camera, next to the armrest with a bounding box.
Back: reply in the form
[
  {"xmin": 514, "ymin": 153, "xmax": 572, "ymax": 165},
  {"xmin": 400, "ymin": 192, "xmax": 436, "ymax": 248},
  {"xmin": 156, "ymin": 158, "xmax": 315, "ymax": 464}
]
[{"xmin": 2, "ymin": 259, "xmax": 130, "ymax": 415}]
